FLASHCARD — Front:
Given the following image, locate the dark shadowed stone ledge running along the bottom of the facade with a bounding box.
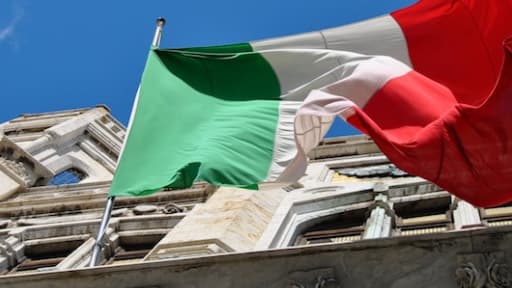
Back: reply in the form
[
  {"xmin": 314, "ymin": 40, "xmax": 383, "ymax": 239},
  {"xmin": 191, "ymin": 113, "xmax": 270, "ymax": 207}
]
[{"xmin": 0, "ymin": 227, "xmax": 512, "ymax": 288}]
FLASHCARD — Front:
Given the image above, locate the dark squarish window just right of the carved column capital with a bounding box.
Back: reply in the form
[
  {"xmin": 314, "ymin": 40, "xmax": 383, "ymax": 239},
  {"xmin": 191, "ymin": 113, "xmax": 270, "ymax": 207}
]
[{"xmin": 394, "ymin": 196, "xmax": 453, "ymax": 235}]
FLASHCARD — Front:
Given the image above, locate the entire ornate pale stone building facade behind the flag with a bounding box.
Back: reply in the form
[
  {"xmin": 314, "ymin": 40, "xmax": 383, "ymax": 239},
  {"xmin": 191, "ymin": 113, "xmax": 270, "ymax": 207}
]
[{"xmin": 0, "ymin": 106, "xmax": 512, "ymax": 288}]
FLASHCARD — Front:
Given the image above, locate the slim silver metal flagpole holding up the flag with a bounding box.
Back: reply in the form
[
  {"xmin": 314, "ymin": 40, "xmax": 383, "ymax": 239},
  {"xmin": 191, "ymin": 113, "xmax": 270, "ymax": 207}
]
[{"xmin": 89, "ymin": 17, "xmax": 165, "ymax": 267}]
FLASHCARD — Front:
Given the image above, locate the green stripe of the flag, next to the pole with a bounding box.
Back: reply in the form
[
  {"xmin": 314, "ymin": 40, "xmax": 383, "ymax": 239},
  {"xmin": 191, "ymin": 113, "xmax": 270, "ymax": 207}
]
[{"xmin": 110, "ymin": 46, "xmax": 280, "ymax": 196}]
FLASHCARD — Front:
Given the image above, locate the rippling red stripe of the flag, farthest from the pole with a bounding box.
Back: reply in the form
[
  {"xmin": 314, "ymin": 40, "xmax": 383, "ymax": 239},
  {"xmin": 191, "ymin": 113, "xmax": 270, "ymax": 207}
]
[{"xmin": 348, "ymin": 0, "xmax": 512, "ymax": 206}]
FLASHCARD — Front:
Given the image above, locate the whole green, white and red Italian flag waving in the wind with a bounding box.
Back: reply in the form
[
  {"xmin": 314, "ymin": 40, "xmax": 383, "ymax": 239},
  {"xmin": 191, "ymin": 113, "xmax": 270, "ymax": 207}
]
[{"xmin": 110, "ymin": 0, "xmax": 512, "ymax": 206}]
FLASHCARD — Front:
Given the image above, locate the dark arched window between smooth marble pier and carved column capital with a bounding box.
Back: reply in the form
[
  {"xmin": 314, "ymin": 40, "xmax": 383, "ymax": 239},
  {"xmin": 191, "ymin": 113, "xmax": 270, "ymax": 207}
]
[{"xmin": 294, "ymin": 209, "xmax": 367, "ymax": 246}]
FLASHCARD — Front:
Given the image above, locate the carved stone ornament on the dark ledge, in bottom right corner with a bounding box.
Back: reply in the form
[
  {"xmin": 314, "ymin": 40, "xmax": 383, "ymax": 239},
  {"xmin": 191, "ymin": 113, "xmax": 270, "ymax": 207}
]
[{"xmin": 455, "ymin": 257, "xmax": 512, "ymax": 288}]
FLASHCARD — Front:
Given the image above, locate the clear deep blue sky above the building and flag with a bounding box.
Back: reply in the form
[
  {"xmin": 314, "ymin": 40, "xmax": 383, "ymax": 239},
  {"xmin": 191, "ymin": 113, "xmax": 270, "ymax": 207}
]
[{"xmin": 0, "ymin": 0, "xmax": 416, "ymax": 135}]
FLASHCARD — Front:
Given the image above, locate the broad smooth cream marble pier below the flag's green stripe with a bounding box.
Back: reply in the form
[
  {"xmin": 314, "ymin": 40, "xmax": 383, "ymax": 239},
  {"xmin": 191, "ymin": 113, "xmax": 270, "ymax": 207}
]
[{"xmin": 146, "ymin": 188, "xmax": 286, "ymax": 260}]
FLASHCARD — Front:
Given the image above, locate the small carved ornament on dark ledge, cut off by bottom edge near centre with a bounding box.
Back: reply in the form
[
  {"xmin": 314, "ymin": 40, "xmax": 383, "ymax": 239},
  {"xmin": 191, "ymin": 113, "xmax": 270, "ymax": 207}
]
[{"xmin": 286, "ymin": 268, "xmax": 341, "ymax": 288}]
